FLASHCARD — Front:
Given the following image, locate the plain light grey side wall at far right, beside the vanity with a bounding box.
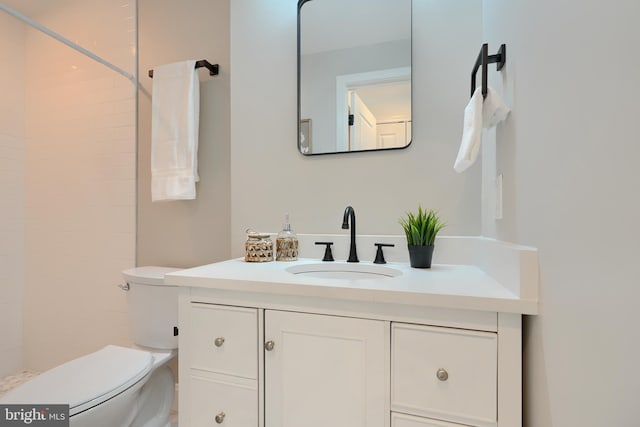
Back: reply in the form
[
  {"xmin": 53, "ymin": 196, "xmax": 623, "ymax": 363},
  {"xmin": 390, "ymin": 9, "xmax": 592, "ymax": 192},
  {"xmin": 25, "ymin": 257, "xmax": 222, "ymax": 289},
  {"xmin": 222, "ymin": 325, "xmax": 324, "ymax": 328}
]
[{"xmin": 483, "ymin": 0, "xmax": 640, "ymax": 427}]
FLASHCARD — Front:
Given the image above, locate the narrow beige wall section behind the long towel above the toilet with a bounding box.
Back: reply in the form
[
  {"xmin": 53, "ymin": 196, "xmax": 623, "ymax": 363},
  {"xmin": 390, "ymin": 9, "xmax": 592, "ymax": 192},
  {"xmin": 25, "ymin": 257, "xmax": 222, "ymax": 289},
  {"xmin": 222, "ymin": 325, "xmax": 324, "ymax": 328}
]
[{"xmin": 137, "ymin": 0, "xmax": 231, "ymax": 267}]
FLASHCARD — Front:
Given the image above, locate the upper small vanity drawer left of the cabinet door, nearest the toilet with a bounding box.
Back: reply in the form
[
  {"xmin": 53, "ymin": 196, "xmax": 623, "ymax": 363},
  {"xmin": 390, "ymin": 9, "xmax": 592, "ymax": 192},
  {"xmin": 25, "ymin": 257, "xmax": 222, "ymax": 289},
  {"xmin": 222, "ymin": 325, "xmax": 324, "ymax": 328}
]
[{"xmin": 190, "ymin": 303, "xmax": 258, "ymax": 379}]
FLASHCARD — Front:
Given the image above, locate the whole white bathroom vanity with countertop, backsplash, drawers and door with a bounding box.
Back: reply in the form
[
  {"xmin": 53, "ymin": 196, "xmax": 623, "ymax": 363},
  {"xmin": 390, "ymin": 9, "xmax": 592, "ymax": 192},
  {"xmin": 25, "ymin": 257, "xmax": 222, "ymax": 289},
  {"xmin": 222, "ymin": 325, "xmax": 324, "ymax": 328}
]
[{"xmin": 165, "ymin": 237, "xmax": 538, "ymax": 427}]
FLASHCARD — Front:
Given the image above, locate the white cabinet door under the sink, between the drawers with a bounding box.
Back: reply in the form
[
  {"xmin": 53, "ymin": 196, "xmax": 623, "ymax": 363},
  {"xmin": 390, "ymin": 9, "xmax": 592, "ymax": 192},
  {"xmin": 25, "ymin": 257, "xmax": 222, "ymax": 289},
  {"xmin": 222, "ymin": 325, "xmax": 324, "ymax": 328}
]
[{"xmin": 265, "ymin": 311, "xmax": 390, "ymax": 427}]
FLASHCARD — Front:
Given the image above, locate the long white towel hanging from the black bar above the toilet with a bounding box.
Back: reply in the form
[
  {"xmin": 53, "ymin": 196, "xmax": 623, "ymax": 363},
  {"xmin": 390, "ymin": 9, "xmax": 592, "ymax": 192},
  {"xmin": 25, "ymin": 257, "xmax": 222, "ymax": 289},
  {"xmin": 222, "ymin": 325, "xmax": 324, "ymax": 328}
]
[{"xmin": 151, "ymin": 60, "xmax": 200, "ymax": 202}]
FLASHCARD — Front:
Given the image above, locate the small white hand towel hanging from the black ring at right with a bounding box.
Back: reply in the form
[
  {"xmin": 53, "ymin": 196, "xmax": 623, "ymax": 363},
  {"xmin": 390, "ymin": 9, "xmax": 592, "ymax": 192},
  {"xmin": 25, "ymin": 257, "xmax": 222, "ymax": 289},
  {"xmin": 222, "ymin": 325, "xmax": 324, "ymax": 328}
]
[{"xmin": 453, "ymin": 87, "xmax": 510, "ymax": 173}]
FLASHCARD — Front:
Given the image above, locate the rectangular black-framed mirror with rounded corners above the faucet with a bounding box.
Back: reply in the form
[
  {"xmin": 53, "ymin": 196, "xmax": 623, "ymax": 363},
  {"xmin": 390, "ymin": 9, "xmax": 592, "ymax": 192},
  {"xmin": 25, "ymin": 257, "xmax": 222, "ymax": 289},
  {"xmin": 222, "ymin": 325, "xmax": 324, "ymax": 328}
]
[{"xmin": 298, "ymin": 0, "xmax": 411, "ymax": 155}]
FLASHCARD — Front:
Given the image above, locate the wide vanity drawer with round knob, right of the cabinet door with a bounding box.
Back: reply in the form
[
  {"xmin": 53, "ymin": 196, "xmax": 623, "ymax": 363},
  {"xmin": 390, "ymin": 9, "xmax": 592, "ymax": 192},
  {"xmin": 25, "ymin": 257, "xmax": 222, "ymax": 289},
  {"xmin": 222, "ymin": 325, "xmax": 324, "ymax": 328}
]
[{"xmin": 391, "ymin": 323, "xmax": 498, "ymax": 426}]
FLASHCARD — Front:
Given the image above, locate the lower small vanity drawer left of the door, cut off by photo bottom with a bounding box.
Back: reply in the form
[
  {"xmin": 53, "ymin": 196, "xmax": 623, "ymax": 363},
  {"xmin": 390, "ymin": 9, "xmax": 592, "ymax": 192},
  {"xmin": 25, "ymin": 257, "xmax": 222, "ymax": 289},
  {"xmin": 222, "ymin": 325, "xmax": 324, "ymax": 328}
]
[{"xmin": 188, "ymin": 376, "xmax": 258, "ymax": 427}]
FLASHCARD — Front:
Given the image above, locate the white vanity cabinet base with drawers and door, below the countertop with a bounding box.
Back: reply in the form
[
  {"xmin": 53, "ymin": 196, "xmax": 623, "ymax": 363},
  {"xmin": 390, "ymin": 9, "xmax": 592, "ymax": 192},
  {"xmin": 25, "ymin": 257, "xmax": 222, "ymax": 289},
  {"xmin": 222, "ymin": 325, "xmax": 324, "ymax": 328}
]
[{"xmin": 180, "ymin": 290, "xmax": 521, "ymax": 427}]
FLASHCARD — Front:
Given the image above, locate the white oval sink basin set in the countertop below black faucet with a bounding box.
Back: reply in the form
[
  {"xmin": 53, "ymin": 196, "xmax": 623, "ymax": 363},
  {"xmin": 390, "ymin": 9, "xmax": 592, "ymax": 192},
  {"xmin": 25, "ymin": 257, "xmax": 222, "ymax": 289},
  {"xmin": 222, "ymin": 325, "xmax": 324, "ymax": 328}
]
[{"xmin": 286, "ymin": 262, "xmax": 402, "ymax": 280}]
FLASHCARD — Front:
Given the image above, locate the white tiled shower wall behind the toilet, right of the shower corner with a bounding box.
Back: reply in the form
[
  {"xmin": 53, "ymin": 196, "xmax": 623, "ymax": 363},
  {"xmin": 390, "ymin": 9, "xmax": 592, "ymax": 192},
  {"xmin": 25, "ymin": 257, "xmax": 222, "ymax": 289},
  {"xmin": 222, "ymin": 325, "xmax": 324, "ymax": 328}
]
[{"xmin": 24, "ymin": 0, "xmax": 136, "ymax": 370}]
